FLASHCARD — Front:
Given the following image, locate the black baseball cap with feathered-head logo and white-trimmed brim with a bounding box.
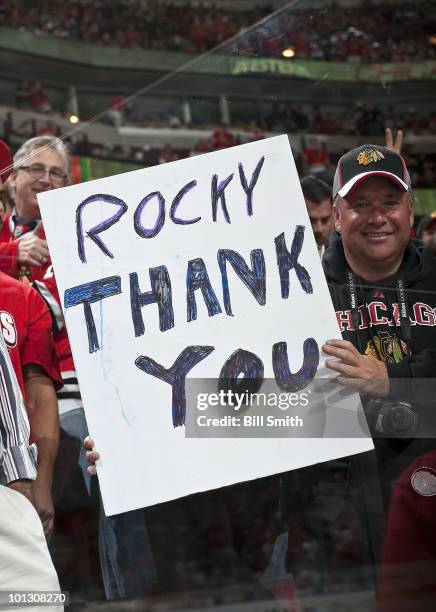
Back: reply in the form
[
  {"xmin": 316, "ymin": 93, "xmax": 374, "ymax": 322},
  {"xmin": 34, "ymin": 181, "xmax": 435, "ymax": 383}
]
[{"xmin": 333, "ymin": 145, "xmax": 411, "ymax": 199}]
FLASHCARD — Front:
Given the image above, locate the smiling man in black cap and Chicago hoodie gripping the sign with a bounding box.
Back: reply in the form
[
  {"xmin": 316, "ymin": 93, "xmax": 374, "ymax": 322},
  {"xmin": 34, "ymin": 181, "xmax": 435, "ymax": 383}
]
[{"xmin": 323, "ymin": 145, "xmax": 436, "ymax": 502}]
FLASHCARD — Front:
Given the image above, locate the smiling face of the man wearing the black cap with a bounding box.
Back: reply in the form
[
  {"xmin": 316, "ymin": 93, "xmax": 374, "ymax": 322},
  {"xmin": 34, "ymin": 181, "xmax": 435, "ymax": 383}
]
[{"xmin": 334, "ymin": 176, "xmax": 413, "ymax": 278}]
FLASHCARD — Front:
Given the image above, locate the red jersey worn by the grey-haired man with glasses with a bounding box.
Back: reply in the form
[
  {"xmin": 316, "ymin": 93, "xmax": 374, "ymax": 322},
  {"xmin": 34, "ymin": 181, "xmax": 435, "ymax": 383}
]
[{"xmin": 0, "ymin": 213, "xmax": 74, "ymax": 391}]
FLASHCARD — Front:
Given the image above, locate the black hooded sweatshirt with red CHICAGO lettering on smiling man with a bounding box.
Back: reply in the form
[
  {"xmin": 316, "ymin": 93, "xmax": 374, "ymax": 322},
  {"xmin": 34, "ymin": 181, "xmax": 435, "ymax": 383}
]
[{"xmin": 323, "ymin": 232, "xmax": 436, "ymax": 435}]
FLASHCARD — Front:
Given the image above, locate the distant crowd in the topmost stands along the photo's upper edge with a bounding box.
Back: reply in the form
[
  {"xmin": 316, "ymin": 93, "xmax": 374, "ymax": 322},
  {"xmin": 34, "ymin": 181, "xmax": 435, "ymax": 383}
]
[{"xmin": 0, "ymin": 0, "xmax": 436, "ymax": 63}]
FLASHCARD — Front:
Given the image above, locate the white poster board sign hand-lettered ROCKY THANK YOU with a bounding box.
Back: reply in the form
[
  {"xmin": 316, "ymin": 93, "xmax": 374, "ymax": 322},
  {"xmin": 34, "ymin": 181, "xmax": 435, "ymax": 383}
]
[{"xmin": 38, "ymin": 136, "xmax": 372, "ymax": 515}]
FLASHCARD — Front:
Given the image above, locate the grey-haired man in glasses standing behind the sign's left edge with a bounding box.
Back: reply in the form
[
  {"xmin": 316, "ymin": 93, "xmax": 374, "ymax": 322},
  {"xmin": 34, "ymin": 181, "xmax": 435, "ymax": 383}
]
[{"xmin": 0, "ymin": 136, "xmax": 155, "ymax": 599}]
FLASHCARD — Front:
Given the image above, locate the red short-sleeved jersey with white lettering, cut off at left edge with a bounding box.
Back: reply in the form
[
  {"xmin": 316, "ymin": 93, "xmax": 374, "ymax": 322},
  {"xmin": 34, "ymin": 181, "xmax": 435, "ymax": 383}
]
[{"xmin": 0, "ymin": 272, "xmax": 62, "ymax": 397}]
